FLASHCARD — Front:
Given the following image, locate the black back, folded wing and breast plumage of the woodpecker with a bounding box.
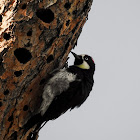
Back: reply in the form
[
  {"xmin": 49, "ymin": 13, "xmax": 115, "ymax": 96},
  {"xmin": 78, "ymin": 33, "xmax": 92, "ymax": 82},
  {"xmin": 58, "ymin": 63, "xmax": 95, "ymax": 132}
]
[{"xmin": 44, "ymin": 66, "xmax": 94, "ymax": 120}]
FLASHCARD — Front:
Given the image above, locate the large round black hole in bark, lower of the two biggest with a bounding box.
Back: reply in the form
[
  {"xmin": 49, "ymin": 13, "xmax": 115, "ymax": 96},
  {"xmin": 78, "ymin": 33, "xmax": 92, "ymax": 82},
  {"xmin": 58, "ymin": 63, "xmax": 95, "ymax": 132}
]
[{"xmin": 14, "ymin": 48, "xmax": 32, "ymax": 64}]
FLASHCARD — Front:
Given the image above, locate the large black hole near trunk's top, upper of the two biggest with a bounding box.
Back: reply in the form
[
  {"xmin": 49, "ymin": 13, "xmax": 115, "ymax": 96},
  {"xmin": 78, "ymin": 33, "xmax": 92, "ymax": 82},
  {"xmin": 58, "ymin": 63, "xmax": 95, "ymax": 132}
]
[{"xmin": 36, "ymin": 9, "xmax": 54, "ymax": 23}]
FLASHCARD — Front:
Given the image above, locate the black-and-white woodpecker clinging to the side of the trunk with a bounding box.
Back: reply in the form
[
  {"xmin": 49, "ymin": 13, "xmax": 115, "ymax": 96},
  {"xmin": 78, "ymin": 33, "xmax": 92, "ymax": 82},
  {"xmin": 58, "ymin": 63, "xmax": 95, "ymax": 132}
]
[{"xmin": 24, "ymin": 52, "xmax": 95, "ymax": 139}]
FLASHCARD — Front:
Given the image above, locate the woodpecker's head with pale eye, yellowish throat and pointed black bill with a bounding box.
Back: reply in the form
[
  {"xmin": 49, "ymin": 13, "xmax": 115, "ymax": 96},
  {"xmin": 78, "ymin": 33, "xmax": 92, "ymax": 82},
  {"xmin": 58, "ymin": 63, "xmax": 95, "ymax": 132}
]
[{"xmin": 71, "ymin": 52, "xmax": 95, "ymax": 71}]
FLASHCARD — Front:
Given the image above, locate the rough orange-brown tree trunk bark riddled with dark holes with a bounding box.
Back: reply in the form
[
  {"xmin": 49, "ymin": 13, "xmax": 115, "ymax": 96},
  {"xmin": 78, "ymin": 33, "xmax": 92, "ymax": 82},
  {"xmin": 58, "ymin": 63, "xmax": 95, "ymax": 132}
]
[{"xmin": 0, "ymin": 0, "xmax": 92, "ymax": 140}]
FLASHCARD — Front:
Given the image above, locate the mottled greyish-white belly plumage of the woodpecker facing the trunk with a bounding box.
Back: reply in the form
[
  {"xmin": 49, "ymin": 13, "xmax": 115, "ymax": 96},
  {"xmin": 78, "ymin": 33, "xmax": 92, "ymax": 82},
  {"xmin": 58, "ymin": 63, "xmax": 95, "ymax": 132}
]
[{"xmin": 40, "ymin": 69, "xmax": 76, "ymax": 115}]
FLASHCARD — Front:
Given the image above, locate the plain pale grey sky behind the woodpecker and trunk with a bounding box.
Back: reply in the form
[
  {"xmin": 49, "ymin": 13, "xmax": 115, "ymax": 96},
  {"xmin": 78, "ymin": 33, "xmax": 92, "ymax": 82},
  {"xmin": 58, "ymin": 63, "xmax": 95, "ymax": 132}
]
[{"xmin": 39, "ymin": 0, "xmax": 140, "ymax": 140}]
